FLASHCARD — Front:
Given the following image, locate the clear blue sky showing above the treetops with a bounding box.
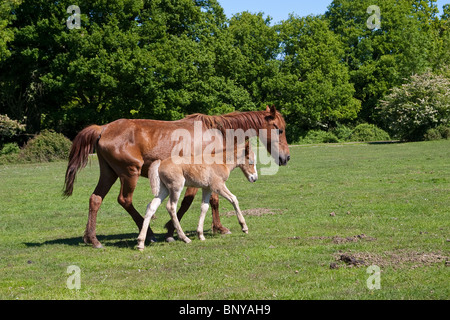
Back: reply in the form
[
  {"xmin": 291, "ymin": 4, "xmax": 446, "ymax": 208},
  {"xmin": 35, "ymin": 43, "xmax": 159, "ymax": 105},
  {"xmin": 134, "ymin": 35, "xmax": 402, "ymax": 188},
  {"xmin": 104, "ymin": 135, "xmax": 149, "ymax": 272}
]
[{"xmin": 219, "ymin": 0, "xmax": 449, "ymax": 24}]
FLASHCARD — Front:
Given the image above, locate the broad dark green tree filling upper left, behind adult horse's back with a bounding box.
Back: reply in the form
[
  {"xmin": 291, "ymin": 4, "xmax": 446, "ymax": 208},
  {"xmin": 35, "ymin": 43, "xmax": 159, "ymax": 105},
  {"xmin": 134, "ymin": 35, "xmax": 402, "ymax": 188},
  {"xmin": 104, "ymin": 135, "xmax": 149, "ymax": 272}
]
[{"xmin": 0, "ymin": 0, "xmax": 248, "ymax": 136}]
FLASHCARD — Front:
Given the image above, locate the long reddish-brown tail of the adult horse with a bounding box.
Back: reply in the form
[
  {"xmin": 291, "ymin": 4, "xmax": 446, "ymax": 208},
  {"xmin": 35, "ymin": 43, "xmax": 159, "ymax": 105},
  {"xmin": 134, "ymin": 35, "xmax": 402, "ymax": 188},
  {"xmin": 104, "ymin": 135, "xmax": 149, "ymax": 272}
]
[{"xmin": 64, "ymin": 125, "xmax": 102, "ymax": 197}]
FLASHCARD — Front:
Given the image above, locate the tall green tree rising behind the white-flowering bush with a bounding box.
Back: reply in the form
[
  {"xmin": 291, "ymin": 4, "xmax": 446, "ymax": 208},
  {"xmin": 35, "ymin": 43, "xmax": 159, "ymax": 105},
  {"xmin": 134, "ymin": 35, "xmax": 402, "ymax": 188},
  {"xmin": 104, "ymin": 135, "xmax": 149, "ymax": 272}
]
[{"xmin": 325, "ymin": 0, "xmax": 438, "ymax": 122}]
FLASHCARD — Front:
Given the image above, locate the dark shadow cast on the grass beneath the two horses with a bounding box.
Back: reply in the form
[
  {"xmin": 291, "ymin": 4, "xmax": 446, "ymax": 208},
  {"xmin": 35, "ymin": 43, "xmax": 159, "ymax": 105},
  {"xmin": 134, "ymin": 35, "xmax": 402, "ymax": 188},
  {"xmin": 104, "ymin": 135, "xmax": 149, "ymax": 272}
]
[{"xmin": 24, "ymin": 233, "xmax": 171, "ymax": 249}]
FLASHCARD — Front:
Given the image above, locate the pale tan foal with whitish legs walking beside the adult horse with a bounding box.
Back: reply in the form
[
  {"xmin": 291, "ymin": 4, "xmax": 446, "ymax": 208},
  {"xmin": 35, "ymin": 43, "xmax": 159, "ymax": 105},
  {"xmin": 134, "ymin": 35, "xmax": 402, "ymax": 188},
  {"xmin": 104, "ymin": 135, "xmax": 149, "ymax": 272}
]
[{"xmin": 137, "ymin": 141, "xmax": 258, "ymax": 251}]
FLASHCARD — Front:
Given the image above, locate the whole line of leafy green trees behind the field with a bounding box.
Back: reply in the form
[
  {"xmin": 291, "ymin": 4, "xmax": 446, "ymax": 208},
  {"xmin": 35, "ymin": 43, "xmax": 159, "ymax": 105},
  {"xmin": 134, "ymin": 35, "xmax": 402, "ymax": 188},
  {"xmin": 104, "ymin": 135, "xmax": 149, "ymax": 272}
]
[{"xmin": 0, "ymin": 0, "xmax": 450, "ymax": 142}]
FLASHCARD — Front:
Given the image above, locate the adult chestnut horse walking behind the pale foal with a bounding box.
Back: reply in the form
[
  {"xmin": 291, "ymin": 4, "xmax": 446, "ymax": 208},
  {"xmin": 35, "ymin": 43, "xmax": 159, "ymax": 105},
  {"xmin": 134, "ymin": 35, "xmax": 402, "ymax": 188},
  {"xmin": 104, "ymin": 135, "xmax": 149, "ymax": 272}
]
[{"xmin": 64, "ymin": 106, "xmax": 290, "ymax": 248}]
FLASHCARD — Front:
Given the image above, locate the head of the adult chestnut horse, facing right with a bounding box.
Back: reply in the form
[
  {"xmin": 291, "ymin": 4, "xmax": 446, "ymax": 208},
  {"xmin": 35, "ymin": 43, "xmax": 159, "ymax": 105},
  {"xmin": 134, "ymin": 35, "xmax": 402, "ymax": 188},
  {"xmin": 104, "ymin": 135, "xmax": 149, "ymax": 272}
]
[{"xmin": 259, "ymin": 106, "xmax": 291, "ymax": 166}]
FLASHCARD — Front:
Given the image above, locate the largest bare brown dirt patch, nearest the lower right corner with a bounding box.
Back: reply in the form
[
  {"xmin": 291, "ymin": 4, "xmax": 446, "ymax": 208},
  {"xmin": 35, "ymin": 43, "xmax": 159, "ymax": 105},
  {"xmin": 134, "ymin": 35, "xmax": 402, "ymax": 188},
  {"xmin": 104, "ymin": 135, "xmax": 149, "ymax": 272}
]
[{"xmin": 330, "ymin": 250, "xmax": 449, "ymax": 269}]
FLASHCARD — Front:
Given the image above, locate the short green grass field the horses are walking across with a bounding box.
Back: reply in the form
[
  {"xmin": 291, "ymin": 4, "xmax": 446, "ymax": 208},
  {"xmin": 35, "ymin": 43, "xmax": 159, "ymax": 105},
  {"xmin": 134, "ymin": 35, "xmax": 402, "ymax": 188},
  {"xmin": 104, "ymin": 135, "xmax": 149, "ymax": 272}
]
[{"xmin": 0, "ymin": 141, "xmax": 450, "ymax": 300}]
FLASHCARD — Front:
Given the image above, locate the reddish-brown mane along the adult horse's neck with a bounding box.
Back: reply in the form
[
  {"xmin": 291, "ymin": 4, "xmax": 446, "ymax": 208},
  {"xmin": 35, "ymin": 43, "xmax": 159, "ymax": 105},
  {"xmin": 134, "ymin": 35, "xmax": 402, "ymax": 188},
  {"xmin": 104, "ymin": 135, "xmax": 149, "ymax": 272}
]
[{"xmin": 185, "ymin": 111, "xmax": 284, "ymax": 131}]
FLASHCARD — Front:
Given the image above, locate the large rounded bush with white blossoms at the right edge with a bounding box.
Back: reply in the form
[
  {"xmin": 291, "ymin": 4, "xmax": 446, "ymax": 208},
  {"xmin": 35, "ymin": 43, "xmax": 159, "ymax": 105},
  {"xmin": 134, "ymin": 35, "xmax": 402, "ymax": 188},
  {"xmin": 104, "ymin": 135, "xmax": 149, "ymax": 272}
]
[{"xmin": 379, "ymin": 68, "xmax": 450, "ymax": 141}]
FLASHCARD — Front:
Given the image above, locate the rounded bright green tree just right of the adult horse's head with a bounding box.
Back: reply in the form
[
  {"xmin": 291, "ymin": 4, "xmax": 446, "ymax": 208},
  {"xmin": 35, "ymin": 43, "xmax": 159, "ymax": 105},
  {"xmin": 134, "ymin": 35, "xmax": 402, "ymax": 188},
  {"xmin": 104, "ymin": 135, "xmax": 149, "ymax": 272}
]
[{"xmin": 272, "ymin": 15, "xmax": 360, "ymax": 140}]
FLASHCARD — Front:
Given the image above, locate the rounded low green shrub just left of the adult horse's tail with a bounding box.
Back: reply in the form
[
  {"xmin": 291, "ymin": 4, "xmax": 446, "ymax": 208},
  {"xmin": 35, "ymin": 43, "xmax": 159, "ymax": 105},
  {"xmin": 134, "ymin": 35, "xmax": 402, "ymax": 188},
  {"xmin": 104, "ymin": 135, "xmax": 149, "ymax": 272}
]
[{"xmin": 20, "ymin": 130, "xmax": 72, "ymax": 162}]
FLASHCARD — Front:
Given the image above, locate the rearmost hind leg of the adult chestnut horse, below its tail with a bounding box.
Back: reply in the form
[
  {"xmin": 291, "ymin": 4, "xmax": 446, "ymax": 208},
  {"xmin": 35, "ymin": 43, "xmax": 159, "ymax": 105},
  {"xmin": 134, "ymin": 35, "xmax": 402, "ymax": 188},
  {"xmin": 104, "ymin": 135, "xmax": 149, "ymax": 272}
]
[{"xmin": 83, "ymin": 155, "xmax": 117, "ymax": 248}]
